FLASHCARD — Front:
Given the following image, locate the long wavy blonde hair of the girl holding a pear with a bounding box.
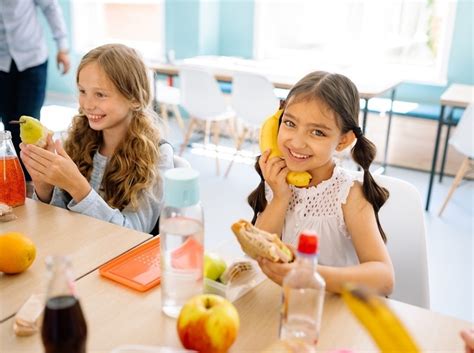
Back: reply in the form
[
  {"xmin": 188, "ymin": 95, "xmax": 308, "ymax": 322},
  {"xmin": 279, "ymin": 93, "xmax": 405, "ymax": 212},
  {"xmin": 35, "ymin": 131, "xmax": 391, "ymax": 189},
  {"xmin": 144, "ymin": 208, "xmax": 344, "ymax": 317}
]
[{"xmin": 64, "ymin": 44, "xmax": 160, "ymax": 210}]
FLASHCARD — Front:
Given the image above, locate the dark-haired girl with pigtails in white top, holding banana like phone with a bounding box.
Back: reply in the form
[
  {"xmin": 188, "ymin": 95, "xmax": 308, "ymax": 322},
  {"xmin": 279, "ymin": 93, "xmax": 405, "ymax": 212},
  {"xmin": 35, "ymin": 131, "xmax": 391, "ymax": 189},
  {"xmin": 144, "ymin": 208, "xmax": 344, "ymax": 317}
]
[{"xmin": 248, "ymin": 71, "xmax": 394, "ymax": 295}]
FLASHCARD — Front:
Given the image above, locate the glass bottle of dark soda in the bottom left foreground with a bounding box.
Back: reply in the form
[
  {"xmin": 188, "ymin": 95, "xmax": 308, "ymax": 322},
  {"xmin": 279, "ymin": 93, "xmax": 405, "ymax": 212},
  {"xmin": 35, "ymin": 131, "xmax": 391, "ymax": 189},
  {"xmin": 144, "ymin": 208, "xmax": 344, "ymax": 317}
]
[{"xmin": 41, "ymin": 256, "xmax": 87, "ymax": 353}]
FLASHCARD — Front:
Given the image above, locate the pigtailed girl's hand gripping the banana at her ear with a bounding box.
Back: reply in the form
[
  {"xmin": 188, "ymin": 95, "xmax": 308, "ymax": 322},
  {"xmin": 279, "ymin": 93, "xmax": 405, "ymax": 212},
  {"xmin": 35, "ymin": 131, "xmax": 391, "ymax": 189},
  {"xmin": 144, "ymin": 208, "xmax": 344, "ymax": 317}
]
[{"xmin": 258, "ymin": 150, "xmax": 291, "ymax": 200}]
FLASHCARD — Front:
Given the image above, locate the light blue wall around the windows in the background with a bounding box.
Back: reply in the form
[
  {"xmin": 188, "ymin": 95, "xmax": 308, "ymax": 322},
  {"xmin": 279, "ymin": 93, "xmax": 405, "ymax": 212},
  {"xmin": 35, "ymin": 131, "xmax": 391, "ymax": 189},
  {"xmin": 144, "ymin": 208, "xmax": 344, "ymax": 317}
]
[{"xmin": 47, "ymin": 0, "xmax": 474, "ymax": 104}]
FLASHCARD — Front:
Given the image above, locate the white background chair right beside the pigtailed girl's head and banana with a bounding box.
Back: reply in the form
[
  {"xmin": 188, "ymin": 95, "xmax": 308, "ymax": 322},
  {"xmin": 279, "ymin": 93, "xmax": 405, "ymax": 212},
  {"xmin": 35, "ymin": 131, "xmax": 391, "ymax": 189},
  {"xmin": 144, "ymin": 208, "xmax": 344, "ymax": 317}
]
[{"xmin": 225, "ymin": 72, "xmax": 279, "ymax": 177}]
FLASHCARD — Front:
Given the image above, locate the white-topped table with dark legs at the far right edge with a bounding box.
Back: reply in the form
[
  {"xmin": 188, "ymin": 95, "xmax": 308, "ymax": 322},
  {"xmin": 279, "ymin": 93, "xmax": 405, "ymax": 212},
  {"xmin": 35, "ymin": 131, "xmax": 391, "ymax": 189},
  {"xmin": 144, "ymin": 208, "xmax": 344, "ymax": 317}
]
[{"xmin": 425, "ymin": 83, "xmax": 474, "ymax": 211}]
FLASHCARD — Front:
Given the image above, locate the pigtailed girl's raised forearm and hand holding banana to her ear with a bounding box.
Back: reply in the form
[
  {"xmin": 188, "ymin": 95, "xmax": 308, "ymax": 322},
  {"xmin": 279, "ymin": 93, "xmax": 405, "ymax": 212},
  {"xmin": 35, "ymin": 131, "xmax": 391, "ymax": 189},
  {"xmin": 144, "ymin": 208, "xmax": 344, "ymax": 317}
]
[{"xmin": 255, "ymin": 150, "xmax": 291, "ymax": 235}]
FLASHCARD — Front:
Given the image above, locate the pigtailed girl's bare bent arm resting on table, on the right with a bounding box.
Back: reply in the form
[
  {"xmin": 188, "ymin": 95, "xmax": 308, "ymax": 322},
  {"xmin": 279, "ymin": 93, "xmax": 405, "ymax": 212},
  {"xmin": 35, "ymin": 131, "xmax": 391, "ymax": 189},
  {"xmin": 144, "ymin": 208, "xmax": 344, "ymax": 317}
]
[{"xmin": 318, "ymin": 182, "xmax": 394, "ymax": 295}]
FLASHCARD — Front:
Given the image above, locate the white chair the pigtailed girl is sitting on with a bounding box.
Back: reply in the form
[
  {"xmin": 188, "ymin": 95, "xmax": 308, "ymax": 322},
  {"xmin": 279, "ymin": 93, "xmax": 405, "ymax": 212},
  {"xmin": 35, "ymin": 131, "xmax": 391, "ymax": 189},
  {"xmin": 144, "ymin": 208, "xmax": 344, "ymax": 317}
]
[{"xmin": 354, "ymin": 172, "xmax": 430, "ymax": 309}]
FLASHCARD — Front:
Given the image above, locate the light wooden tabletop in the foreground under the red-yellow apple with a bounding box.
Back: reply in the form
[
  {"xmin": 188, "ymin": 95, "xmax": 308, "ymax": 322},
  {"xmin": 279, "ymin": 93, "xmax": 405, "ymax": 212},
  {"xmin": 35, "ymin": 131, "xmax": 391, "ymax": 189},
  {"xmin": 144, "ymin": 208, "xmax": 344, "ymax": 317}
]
[{"xmin": 0, "ymin": 271, "xmax": 472, "ymax": 353}]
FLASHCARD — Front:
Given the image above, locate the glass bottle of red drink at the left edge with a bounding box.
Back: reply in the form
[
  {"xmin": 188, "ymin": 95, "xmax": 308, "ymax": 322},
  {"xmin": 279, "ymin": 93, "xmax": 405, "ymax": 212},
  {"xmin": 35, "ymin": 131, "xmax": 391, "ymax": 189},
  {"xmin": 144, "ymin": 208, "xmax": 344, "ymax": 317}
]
[{"xmin": 0, "ymin": 131, "xmax": 26, "ymax": 207}]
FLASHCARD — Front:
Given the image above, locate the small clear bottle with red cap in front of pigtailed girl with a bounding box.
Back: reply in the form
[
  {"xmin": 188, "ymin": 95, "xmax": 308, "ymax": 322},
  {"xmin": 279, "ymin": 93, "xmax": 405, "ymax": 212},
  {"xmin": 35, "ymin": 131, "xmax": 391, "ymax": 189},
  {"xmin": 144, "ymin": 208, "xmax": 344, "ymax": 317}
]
[{"xmin": 280, "ymin": 231, "xmax": 326, "ymax": 344}]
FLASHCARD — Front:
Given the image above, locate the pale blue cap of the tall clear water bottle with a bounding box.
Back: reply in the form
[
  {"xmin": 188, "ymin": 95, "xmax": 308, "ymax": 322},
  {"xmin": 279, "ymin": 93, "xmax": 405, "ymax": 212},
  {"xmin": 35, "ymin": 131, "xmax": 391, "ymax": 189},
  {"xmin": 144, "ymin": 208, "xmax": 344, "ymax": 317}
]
[{"xmin": 163, "ymin": 168, "xmax": 199, "ymax": 207}]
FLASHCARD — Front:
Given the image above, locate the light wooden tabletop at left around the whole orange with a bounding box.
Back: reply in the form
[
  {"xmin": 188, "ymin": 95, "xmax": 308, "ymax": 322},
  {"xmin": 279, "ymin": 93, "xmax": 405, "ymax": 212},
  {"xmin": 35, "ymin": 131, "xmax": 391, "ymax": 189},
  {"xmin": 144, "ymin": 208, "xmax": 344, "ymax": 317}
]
[{"xmin": 0, "ymin": 199, "xmax": 151, "ymax": 322}]
